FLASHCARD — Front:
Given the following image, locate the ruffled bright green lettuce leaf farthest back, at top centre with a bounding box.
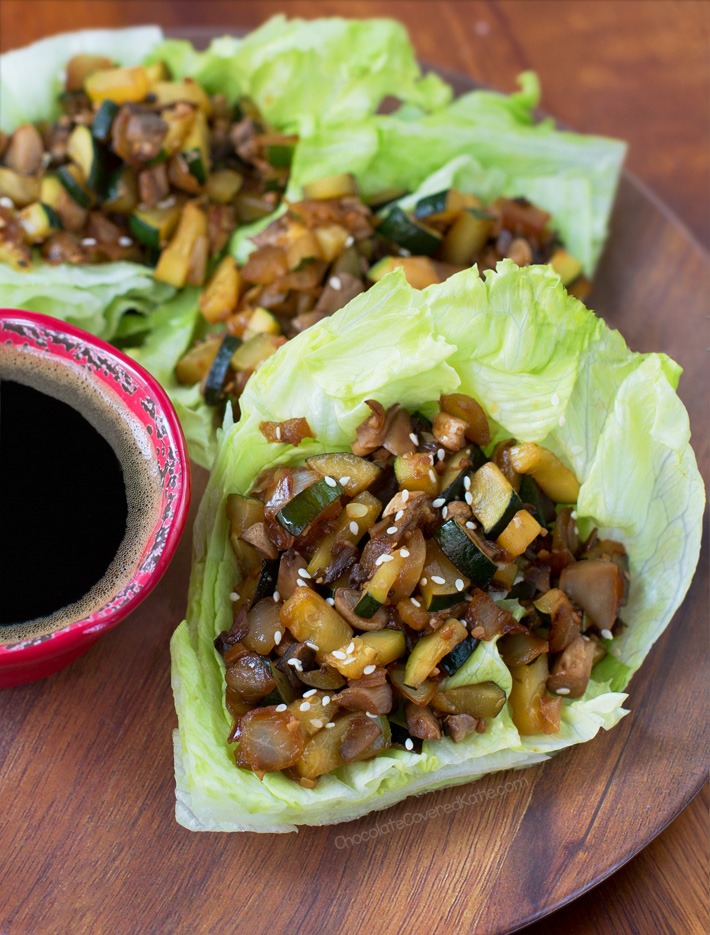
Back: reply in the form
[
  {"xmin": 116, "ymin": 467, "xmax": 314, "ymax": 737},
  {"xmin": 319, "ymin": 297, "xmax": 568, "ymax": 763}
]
[{"xmin": 150, "ymin": 15, "xmax": 451, "ymax": 133}]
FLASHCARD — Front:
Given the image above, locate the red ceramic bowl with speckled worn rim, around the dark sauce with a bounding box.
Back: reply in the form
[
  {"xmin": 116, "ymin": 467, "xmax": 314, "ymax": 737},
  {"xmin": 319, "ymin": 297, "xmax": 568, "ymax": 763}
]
[{"xmin": 0, "ymin": 309, "xmax": 190, "ymax": 688}]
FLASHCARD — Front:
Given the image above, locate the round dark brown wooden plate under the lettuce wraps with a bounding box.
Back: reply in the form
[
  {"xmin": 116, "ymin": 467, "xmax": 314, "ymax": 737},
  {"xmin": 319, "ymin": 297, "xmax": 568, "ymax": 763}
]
[{"xmin": 0, "ymin": 67, "xmax": 710, "ymax": 935}]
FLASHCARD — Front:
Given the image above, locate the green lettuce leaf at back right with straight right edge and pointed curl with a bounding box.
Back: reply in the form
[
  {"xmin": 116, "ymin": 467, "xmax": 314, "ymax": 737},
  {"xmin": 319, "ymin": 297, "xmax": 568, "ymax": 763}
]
[{"xmin": 289, "ymin": 73, "xmax": 626, "ymax": 276}]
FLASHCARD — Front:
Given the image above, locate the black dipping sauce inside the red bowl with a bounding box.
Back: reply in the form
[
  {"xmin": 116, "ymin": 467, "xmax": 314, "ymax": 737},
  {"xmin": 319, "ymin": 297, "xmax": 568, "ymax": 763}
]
[{"xmin": 0, "ymin": 380, "xmax": 128, "ymax": 625}]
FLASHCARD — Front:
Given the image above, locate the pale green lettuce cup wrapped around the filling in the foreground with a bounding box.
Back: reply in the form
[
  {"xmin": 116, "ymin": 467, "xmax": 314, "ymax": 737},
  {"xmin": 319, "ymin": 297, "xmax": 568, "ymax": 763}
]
[{"xmin": 171, "ymin": 261, "xmax": 704, "ymax": 832}]
